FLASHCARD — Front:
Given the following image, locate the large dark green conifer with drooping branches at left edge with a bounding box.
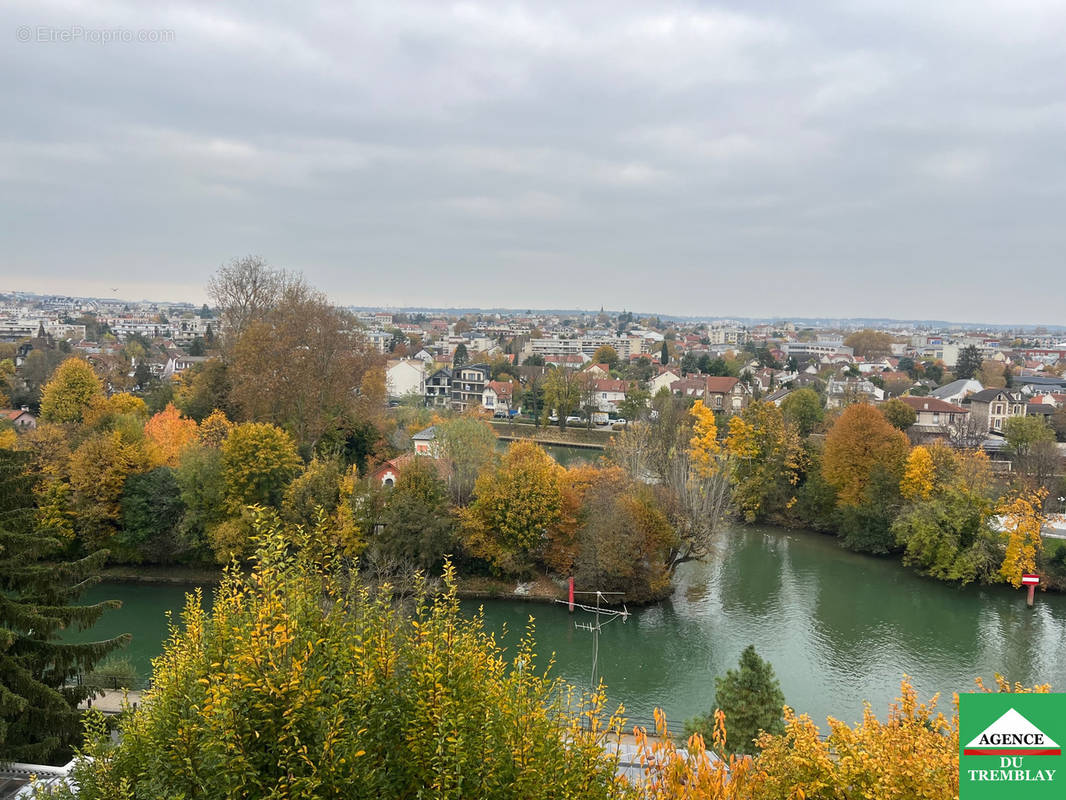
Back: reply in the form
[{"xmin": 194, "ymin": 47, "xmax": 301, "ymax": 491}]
[{"xmin": 0, "ymin": 450, "xmax": 129, "ymax": 764}]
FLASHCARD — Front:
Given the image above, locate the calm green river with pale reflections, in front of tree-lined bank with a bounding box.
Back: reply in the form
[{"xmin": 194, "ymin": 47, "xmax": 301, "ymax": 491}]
[{"xmin": 66, "ymin": 528, "xmax": 1066, "ymax": 727}]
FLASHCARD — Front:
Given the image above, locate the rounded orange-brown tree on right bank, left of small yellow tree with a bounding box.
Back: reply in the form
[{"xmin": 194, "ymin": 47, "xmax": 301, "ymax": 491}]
[{"xmin": 822, "ymin": 403, "xmax": 910, "ymax": 506}]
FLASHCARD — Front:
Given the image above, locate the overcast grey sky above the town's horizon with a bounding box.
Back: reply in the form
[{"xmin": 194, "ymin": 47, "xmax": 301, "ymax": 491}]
[{"xmin": 0, "ymin": 0, "xmax": 1066, "ymax": 323}]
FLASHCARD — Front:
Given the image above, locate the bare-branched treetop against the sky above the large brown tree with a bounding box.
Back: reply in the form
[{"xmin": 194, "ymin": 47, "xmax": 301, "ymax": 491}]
[{"xmin": 207, "ymin": 256, "xmax": 300, "ymax": 347}]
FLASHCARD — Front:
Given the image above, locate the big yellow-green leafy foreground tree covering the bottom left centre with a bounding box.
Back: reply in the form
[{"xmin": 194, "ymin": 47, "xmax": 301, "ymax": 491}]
[{"xmin": 54, "ymin": 526, "xmax": 623, "ymax": 800}]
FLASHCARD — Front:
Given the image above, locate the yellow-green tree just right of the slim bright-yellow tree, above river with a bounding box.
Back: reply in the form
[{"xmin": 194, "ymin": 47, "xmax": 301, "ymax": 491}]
[{"xmin": 726, "ymin": 402, "xmax": 803, "ymax": 522}]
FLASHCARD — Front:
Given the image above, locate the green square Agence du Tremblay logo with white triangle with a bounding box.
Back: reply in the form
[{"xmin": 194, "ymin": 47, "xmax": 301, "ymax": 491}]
[{"xmin": 958, "ymin": 693, "xmax": 1066, "ymax": 800}]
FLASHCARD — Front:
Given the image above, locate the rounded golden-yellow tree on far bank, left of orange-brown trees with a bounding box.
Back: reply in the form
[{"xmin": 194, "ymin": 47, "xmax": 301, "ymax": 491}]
[{"xmin": 459, "ymin": 441, "xmax": 563, "ymax": 575}]
